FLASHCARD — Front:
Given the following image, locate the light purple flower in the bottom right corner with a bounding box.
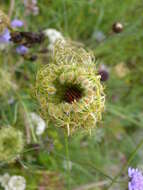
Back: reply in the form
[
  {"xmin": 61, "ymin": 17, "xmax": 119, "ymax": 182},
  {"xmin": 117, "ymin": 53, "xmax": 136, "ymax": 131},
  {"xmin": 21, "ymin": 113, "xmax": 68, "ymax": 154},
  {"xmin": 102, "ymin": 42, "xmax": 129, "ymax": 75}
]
[{"xmin": 128, "ymin": 168, "xmax": 143, "ymax": 190}]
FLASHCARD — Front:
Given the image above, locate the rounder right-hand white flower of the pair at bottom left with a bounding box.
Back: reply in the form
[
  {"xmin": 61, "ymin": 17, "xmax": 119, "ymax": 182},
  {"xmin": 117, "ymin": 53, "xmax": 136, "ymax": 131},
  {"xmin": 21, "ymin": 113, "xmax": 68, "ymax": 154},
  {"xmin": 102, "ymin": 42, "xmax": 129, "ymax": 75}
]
[{"xmin": 8, "ymin": 176, "xmax": 26, "ymax": 190}]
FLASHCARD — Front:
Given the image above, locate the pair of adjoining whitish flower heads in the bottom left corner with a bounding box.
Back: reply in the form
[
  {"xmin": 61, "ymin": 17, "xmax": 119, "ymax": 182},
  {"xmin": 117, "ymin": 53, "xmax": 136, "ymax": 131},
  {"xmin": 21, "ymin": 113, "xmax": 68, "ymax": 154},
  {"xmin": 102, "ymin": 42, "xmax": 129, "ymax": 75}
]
[{"xmin": 0, "ymin": 173, "xmax": 26, "ymax": 190}]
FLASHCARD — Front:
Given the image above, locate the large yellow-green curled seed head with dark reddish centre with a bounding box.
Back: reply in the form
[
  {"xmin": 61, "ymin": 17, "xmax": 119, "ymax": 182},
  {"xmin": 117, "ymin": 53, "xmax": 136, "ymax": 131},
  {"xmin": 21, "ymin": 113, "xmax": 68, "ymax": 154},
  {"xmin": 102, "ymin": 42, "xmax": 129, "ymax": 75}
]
[{"xmin": 36, "ymin": 42, "xmax": 105, "ymax": 134}]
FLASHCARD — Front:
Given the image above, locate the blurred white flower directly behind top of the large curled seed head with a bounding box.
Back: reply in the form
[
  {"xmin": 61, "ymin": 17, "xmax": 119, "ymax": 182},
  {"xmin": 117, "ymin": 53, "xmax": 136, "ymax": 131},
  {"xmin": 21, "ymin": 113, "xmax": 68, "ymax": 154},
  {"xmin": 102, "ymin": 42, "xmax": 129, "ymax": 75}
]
[{"xmin": 44, "ymin": 28, "xmax": 65, "ymax": 50}]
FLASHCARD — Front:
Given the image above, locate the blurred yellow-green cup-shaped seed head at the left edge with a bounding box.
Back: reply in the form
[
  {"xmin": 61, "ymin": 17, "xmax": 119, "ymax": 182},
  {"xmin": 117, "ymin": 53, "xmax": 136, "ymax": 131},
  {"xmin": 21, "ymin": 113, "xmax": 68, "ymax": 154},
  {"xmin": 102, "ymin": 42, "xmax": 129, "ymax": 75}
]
[{"xmin": 0, "ymin": 127, "xmax": 24, "ymax": 162}]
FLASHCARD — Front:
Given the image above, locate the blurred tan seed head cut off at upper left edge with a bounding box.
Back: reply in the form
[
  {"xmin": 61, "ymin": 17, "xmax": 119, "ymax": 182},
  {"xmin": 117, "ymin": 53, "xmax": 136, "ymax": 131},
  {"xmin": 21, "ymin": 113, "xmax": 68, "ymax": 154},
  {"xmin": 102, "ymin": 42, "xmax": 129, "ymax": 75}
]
[{"xmin": 0, "ymin": 10, "xmax": 10, "ymax": 34}]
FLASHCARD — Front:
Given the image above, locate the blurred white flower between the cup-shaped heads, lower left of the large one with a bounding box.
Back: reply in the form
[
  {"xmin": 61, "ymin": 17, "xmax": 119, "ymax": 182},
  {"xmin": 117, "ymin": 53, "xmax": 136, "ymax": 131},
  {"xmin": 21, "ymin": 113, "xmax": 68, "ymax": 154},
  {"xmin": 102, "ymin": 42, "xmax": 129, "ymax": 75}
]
[{"xmin": 30, "ymin": 112, "xmax": 46, "ymax": 136}]
